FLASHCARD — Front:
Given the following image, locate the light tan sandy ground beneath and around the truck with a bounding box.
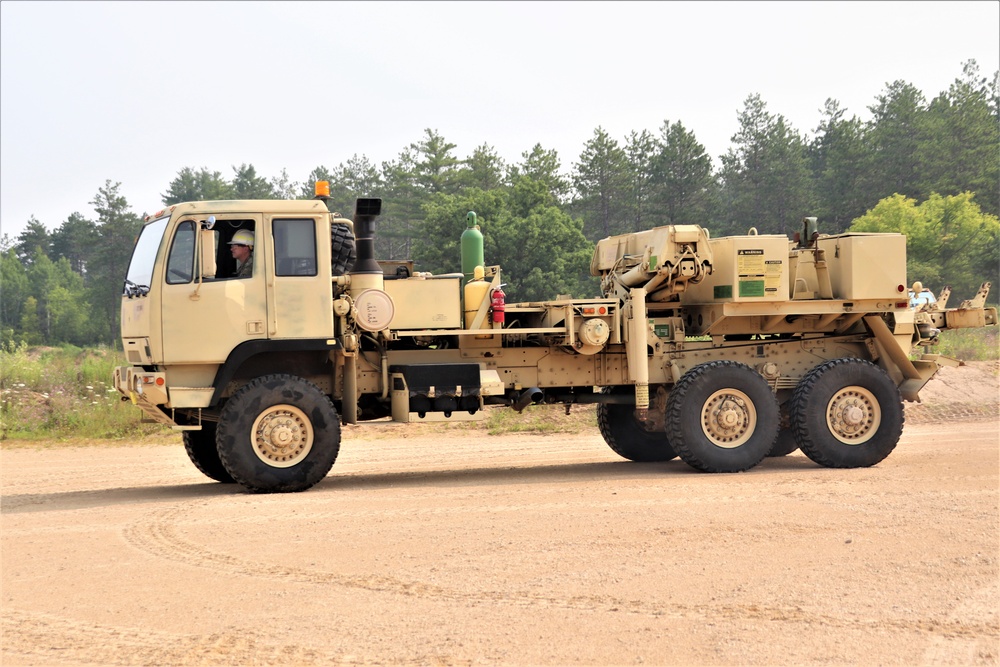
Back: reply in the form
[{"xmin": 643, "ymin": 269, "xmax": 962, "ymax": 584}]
[{"xmin": 0, "ymin": 365, "xmax": 1000, "ymax": 666}]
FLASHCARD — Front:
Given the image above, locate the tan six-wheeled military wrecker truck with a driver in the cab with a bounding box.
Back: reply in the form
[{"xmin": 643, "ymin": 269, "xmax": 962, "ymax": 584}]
[{"xmin": 114, "ymin": 183, "xmax": 997, "ymax": 492}]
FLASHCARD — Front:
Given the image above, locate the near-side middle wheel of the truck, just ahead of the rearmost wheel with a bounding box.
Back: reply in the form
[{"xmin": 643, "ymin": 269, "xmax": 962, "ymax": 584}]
[{"xmin": 667, "ymin": 361, "xmax": 780, "ymax": 472}]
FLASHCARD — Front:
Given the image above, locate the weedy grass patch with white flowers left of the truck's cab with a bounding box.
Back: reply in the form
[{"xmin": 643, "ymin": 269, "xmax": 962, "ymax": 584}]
[{"xmin": 0, "ymin": 344, "xmax": 165, "ymax": 446}]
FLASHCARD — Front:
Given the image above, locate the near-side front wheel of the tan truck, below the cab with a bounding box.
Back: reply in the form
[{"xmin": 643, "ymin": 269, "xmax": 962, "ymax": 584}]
[{"xmin": 216, "ymin": 374, "xmax": 340, "ymax": 493}]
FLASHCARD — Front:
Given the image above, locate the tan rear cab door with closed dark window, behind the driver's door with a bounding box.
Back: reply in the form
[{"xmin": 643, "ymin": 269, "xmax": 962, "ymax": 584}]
[{"xmin": 265, "ymin": 214, "xmax": 333, "ymax": 339}]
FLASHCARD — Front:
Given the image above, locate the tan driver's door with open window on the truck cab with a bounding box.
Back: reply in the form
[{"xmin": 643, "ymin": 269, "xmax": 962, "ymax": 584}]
[{"xmin": 162, "ymin": 214, "xmax": 268, "ymax": 364}]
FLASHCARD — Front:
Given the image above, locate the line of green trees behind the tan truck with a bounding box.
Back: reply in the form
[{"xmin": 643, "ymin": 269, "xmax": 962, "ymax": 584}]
[{"xmin": 0, "ymin": 60, "xmax": 1000, "ymax": 345}]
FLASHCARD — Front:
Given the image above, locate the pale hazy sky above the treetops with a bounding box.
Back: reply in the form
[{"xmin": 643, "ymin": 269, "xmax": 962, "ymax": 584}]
[{"xmin": 0, "ymin": 0, "xmax": 1000, "ymax": 237}]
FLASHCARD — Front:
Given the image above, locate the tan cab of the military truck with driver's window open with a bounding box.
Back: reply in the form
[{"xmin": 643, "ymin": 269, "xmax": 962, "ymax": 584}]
[{"xmin": 119, "ymin": 200, "xmax": 351, "ymax": 426}]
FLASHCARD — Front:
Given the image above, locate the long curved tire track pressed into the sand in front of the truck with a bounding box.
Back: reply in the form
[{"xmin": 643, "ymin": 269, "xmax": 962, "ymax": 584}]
[{"xmin": 123, "ymin": 501, "xmax": 1000, "ymax": 639}]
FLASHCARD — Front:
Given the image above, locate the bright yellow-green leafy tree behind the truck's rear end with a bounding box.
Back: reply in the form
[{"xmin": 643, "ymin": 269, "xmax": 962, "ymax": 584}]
[{"xmin": 851, "ymin": 192, "xmax": 1000, "ymax": 298}]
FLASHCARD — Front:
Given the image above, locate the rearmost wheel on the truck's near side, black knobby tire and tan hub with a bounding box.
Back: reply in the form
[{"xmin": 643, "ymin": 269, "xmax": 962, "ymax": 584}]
[{"xmin": 790, "ymin": 358, "xmax": 904, "ymax": 468}]
